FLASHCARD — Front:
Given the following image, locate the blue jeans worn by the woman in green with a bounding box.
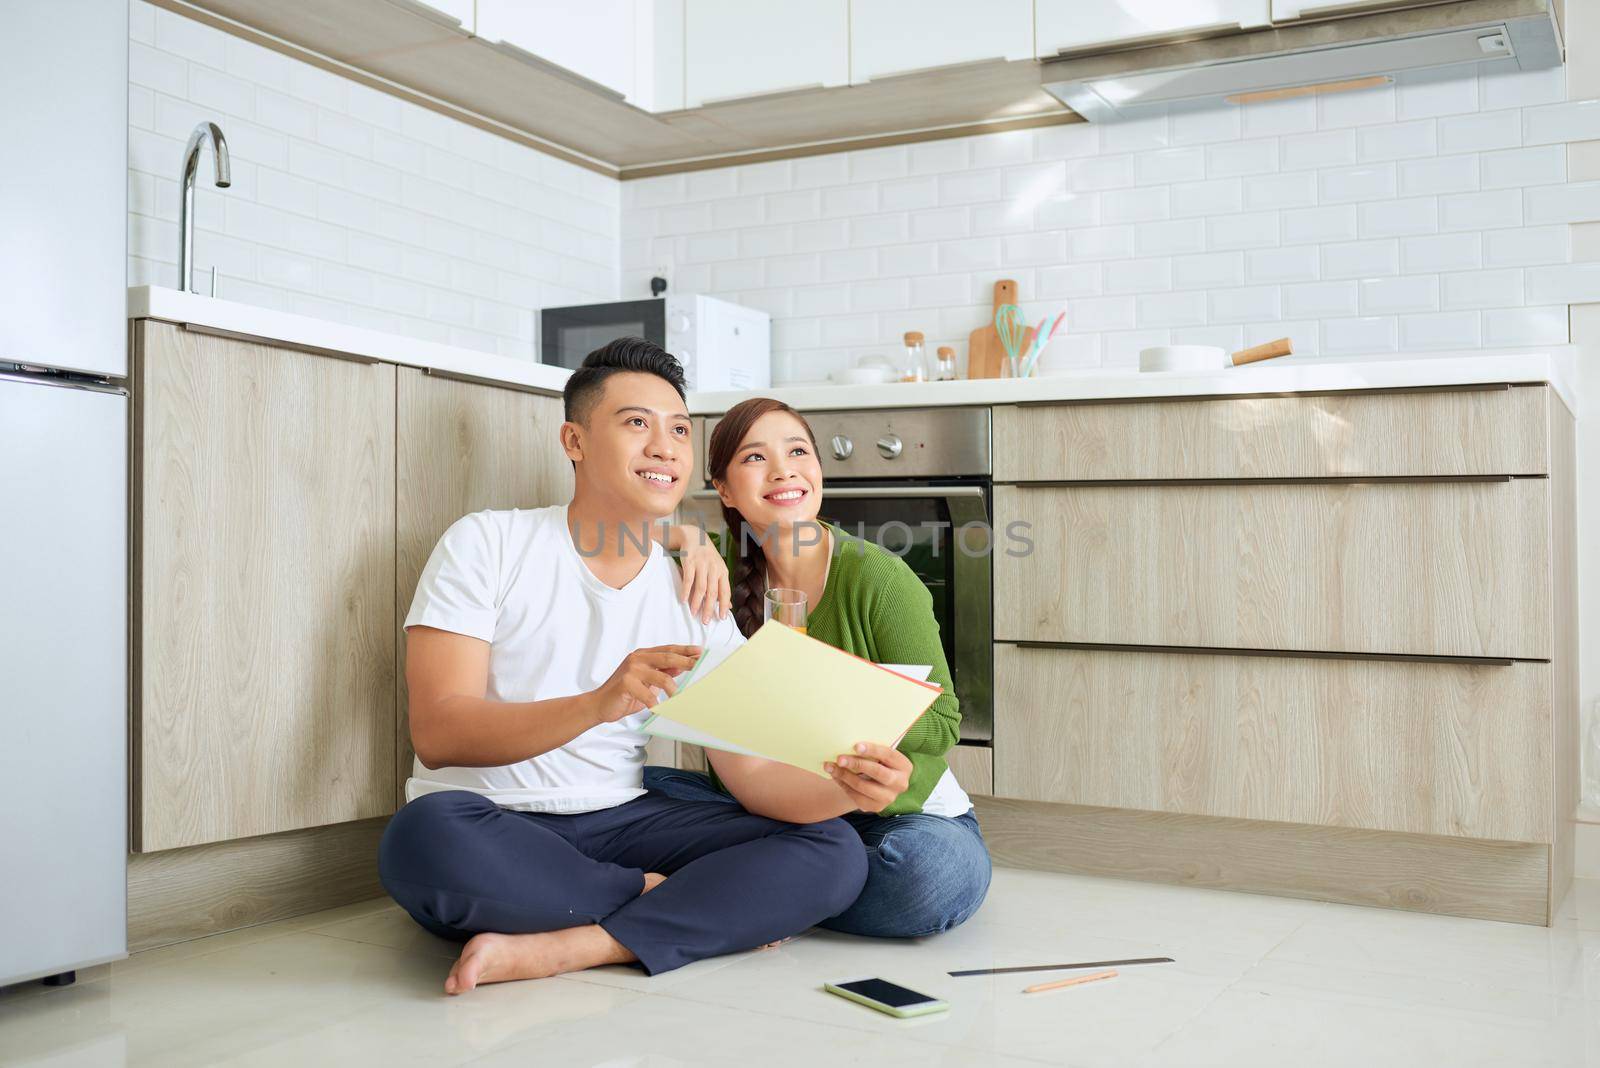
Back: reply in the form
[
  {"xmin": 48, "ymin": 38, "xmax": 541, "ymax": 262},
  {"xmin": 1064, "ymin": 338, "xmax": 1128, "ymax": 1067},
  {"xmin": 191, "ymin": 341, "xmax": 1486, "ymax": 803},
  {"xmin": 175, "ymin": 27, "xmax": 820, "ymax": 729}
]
[{"xmin": 645, "ymin": 766, "xmax": 990, "ymax": 938}]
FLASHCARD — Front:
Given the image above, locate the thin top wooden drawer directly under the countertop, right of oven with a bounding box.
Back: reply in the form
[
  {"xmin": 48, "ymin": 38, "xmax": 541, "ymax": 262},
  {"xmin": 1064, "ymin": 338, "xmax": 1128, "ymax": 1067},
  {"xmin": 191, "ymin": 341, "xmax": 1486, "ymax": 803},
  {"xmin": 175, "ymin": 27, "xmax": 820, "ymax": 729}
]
[{"xmin": 994, "ymin": 385, "xmax": 1550, "ymax": 481}]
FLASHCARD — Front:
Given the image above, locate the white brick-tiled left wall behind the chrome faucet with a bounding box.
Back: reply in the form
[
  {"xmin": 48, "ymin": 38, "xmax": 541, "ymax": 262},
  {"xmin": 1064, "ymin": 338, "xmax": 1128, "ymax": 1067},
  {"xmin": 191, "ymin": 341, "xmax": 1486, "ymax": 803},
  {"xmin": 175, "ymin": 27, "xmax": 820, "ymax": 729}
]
[{"xmin": 128, "ymin": 0, "xmax": 621, "ymax": 360}]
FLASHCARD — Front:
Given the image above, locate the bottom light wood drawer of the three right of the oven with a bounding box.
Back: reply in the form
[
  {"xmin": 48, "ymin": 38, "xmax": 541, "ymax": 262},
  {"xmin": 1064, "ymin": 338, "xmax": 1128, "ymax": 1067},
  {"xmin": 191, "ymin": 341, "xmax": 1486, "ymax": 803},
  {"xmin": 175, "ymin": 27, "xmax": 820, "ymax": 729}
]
[{"xmin": 994, "ymin": 644, "xmax": 1552, "ymax": 843}]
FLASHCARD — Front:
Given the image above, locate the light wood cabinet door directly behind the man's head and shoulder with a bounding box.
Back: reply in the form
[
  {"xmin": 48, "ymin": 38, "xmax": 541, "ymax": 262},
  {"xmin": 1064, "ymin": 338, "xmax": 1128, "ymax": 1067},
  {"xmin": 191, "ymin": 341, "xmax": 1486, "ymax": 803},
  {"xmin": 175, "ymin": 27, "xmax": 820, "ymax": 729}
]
[{"xmin": 387, "ymin": 368, "xmax": 573, "ymax": 806}]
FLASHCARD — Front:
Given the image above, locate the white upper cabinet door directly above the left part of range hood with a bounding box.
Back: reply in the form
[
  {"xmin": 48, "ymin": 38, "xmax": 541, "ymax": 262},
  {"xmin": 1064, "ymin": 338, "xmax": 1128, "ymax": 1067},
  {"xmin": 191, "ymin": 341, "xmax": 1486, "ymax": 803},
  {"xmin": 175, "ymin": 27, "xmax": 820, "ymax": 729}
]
[{"xmin": 1034, "ymin": 0, "xmax": 1273, "ymax": 59}]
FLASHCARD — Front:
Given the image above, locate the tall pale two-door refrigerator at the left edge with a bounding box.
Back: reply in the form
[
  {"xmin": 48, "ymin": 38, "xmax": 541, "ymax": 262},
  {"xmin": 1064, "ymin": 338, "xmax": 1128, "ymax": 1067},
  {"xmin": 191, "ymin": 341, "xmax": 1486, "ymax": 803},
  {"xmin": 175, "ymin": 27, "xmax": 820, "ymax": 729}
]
[{"xmin": 0, "ymin": 0, "xmax": 130, "ymax": 985}]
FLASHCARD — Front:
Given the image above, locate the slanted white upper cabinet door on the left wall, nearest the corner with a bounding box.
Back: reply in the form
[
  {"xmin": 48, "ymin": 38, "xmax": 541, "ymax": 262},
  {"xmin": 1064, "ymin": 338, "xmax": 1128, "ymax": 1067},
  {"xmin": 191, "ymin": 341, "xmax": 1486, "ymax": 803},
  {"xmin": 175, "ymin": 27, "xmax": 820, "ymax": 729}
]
[{"xmin": 476, "ymin": 0, "xmax": 650, "ymax": 107}]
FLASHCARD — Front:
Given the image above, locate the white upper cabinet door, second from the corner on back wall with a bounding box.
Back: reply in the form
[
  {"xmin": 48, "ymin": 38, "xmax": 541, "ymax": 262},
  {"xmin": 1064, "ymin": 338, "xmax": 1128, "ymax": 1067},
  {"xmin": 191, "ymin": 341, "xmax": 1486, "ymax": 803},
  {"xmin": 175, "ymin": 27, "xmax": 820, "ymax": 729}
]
[{"xmin": 857, "ymin": 0, "xmax": 1034, "ymax": 85}]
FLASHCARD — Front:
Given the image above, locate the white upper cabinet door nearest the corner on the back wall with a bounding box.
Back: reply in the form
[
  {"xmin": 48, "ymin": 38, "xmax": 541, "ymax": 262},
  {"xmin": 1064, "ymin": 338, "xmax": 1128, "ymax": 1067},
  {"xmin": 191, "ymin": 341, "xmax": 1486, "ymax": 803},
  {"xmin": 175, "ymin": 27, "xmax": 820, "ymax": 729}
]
[{"xmin": 681, "ymin": 0, "xmax": 850, "ymax": 107}]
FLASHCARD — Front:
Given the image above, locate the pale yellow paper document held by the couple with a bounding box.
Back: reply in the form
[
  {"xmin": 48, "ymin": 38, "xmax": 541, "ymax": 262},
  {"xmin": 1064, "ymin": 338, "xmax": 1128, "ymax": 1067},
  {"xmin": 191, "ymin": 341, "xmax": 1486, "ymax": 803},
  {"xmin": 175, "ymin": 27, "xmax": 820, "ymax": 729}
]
[{"xmin": 643, "ymin": 622, "xmax": 944, "ymax": 779}]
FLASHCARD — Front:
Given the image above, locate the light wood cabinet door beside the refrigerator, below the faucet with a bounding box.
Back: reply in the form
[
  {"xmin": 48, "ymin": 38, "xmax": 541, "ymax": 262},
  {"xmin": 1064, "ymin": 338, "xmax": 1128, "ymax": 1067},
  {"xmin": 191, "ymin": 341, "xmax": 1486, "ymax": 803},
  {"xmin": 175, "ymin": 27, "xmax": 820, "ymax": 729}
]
[{"xmin": 131, "ymin": 320, "xmax": 395, "ymax": 852}]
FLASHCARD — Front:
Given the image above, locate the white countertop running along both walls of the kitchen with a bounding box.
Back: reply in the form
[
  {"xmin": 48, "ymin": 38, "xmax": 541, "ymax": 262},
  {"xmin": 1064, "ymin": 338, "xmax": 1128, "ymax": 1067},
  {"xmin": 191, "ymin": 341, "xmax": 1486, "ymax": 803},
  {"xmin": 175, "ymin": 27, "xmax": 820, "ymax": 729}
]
[{"xmin": 128, "ymin": 286, "xmax": 1578, "ymax": 416}]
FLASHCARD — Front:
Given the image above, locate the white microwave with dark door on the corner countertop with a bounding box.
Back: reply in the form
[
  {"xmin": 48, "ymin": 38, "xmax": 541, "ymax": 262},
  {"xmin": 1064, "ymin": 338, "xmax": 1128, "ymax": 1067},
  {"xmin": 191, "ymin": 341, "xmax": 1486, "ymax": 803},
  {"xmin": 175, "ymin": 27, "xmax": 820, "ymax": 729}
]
[{"xmin": 539, "ymin": 294, "xmax": 773, "ymax": 392}]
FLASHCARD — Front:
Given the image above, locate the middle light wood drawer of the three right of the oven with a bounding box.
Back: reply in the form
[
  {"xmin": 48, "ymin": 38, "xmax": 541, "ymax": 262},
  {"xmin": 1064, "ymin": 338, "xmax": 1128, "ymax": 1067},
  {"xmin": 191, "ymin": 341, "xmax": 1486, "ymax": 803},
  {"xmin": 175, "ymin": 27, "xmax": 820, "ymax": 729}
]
[{"xmin": 994, "ymin": 478, "xmax": 1550, "ymax": 659}]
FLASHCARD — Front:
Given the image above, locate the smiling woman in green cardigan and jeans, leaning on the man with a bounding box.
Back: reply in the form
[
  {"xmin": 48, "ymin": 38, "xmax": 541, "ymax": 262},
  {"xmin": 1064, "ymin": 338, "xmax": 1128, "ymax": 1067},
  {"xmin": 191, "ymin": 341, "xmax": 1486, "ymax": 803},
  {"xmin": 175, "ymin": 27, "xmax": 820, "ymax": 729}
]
[{"xmin": 645, "ymin": 398, "xmax": 990, "ymax": 937}]
